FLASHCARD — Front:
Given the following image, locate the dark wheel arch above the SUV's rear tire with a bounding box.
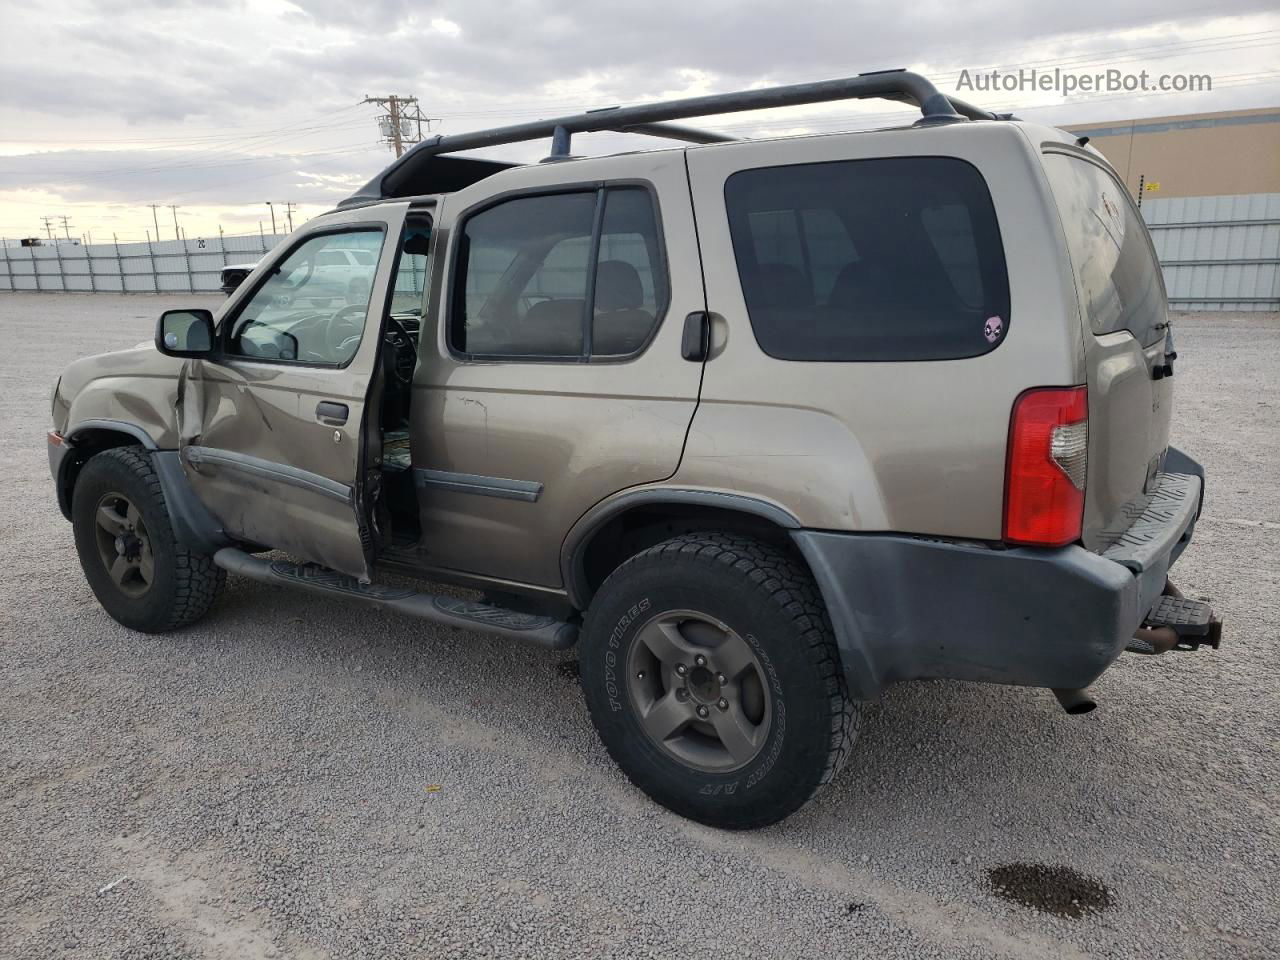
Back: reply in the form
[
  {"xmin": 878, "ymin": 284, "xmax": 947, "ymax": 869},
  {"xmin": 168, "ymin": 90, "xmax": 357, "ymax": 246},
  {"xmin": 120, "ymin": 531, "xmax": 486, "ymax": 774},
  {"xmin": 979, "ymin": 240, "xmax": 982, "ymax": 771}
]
[{"xmin": 561, "ymin": 488, "xmax": 809, "ymax": 611}]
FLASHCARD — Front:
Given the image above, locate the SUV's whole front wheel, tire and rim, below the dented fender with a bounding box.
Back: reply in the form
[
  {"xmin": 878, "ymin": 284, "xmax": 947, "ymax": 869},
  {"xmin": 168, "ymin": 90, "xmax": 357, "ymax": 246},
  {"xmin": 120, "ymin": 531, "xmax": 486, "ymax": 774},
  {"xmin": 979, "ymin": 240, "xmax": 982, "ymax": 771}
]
[{"xmin": 72, "ymin": 447, "xmax": 227, "ymax": 634}]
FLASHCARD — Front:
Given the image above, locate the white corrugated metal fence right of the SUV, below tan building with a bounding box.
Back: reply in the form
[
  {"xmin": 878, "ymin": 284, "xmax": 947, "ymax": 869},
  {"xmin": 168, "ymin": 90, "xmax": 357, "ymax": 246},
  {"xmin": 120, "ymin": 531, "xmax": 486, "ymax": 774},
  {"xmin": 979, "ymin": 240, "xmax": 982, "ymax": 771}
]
[{"xmin": 1142, "ymin": 193, "xmax": 1280, "ymax": 311}]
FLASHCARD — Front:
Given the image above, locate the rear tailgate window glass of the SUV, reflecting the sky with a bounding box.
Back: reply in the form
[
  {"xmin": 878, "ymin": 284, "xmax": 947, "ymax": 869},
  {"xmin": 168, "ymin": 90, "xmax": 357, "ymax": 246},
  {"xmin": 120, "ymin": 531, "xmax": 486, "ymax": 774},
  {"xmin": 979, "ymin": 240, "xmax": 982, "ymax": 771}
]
[{"xmin": 1044, "ymin": 154, "xmax": 1167, "ymax": 346}]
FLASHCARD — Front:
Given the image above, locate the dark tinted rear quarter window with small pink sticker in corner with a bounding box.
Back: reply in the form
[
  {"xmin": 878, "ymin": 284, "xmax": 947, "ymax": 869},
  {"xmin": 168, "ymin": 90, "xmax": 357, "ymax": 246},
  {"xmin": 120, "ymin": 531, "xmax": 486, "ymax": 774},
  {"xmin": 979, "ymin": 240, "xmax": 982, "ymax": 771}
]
[{"xmin": 724, "ymin": 156, "xmax": 1009, "ymax": 361}]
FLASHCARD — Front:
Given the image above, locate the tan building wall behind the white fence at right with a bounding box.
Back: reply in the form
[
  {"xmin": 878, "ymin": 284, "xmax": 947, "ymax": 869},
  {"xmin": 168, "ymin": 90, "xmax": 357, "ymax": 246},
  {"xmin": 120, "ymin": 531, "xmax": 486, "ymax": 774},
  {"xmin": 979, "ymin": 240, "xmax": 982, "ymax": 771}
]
[{"xmin": 1064, "ymin": 106, "xmax": 1280, "ymax": 200}]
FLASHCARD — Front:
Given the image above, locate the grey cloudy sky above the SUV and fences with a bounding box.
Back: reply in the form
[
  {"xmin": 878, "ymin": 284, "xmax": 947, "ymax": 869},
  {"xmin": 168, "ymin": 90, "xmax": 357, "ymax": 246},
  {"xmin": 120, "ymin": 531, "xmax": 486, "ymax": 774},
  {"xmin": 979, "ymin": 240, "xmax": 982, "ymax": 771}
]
[{"xmin": 0, "ymin": 0, "xmax": 1280, "ymax": 241}]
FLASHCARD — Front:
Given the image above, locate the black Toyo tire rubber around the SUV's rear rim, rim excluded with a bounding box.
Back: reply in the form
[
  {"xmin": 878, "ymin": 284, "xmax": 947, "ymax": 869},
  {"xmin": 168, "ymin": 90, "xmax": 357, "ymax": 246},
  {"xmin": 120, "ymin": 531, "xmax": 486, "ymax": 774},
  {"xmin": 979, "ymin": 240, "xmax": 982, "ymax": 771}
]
[{"xmin": 580, "ymin": 532, "xmax": 861, "ymax": 829}]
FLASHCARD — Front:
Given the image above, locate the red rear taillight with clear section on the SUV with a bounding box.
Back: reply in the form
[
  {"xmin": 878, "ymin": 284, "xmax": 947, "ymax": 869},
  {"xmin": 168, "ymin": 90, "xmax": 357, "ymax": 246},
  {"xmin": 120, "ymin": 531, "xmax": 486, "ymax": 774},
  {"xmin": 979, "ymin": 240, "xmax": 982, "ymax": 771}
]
[{"xmin": 1005, "ymin": 387, "xmax": 1089, "ymax": 547}]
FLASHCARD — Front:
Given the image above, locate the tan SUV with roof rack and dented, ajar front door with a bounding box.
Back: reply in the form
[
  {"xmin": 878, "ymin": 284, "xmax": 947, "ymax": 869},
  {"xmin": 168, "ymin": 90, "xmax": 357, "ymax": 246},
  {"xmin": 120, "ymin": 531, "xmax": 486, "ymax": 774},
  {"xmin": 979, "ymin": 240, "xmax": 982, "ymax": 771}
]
[{"xmin": 49, "ymin": 72, "xmax": 1220, "ymax": 827}]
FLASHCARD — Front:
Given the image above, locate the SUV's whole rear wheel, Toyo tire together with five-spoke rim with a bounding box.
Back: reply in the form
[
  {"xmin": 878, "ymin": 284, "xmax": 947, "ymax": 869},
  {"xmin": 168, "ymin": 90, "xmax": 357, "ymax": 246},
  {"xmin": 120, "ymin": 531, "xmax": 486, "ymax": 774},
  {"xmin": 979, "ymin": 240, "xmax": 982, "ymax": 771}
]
[{"xmin": 581, "ymin": 532, "xmax": 861, "ymax": 829}]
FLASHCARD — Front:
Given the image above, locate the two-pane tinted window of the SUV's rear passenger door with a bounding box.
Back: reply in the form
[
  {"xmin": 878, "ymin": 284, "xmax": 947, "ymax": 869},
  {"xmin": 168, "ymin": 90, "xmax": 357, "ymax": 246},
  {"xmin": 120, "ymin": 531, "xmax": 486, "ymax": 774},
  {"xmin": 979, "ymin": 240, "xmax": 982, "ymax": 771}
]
[{"xmin": 451, "ymin": 188, "xmax": 667, "ymax": 357}]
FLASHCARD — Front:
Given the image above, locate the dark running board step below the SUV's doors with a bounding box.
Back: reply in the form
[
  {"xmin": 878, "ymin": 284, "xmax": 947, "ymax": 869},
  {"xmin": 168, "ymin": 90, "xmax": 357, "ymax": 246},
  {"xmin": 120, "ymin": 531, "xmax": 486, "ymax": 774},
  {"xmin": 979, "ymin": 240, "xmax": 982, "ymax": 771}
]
[{"xmin": 214, "ymin": 547, "xmax": 577, "ymax": 650}]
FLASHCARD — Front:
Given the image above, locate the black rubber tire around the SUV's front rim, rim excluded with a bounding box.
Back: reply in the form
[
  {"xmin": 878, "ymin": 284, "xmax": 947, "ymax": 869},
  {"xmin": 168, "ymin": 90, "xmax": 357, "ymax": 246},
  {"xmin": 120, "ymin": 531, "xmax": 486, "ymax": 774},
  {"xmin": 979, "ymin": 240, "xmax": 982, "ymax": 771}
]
[{"xmin": 72, "ymin": 447, "xmax": 227, "ymax": 634}]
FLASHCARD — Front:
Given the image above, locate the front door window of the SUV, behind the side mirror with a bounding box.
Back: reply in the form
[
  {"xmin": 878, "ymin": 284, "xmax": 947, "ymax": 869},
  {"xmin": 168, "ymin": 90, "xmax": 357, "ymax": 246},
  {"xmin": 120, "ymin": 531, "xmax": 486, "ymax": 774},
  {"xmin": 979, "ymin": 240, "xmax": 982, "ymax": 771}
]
[{"xmin": 227, "ymin": 230, "xmax": 383, "ymax": 365}]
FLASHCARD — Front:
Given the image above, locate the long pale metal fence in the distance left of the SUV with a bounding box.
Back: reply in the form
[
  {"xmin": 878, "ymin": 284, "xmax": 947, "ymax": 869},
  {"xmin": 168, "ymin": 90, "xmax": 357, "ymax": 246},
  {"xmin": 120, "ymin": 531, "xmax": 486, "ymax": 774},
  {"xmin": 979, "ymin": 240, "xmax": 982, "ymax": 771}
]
[{"xmin": 0, "ymin": 234, "xmax": 284, "ymax": 293}]
